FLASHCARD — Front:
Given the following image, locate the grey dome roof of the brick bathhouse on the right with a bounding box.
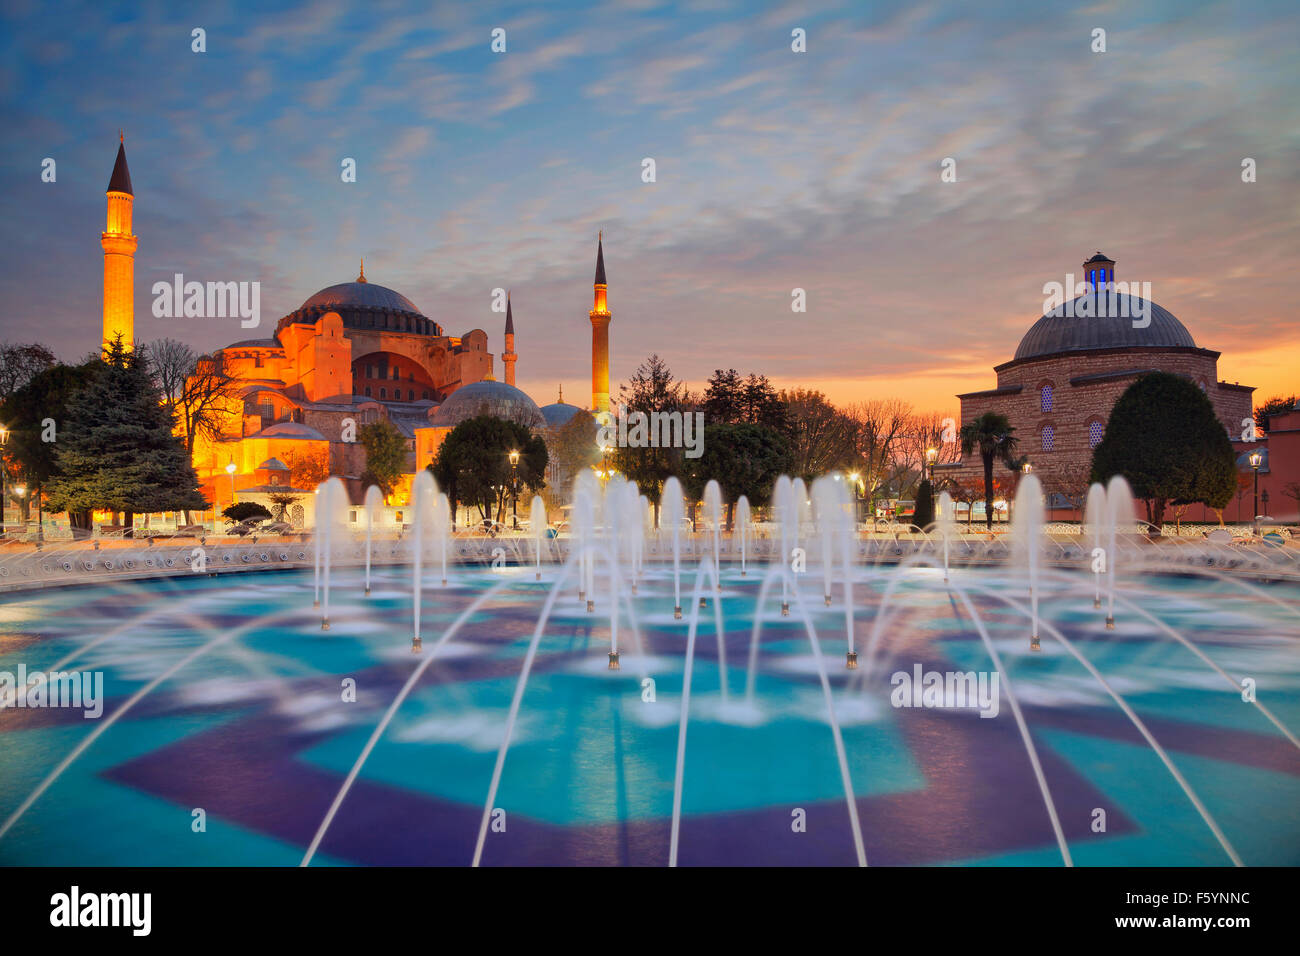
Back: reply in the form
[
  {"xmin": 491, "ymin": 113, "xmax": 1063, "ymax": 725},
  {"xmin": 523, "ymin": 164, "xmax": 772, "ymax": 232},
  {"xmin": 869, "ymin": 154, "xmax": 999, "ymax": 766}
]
[{"xmin": 1013, "ymin": 295, "xmax": 1196, "ymax": 362}]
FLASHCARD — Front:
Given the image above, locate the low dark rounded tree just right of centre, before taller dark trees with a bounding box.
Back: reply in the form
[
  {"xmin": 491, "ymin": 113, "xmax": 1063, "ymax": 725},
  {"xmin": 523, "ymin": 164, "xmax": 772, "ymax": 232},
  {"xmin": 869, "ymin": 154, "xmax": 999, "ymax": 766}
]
[{"xmin": 683, "ymin": 423, "xmax": 790, "ymax": 527}]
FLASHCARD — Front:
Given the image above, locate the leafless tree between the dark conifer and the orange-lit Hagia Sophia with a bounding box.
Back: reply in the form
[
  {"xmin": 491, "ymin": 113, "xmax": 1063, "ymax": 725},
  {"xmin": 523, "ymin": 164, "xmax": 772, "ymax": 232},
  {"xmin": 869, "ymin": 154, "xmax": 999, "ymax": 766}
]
[{"xmin": 146, "ymin": 338, "xmax": 243, "ymax": 460}]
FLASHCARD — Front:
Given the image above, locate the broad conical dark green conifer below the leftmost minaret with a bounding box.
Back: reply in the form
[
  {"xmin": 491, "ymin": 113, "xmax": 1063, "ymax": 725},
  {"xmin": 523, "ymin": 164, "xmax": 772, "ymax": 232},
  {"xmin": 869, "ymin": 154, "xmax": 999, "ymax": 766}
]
[{"xmin": 49, "ymin": 336, "xmax": 208, "ymax": 532}]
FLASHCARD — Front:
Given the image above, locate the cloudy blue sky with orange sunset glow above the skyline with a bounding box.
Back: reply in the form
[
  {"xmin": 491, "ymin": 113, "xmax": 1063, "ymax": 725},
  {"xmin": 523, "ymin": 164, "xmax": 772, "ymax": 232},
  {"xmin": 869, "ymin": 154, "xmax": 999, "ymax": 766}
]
[{"xmin": 0, "ymin": 0, "xmax": 1300, "ymax": 412}]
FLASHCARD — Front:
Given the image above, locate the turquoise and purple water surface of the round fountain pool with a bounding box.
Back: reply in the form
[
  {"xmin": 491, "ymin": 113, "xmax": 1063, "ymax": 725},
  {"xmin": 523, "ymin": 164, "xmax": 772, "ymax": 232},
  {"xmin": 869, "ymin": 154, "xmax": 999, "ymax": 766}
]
[{"xmin": 0, "ymin": 561, "xmax": 1300, "ymax": 866}]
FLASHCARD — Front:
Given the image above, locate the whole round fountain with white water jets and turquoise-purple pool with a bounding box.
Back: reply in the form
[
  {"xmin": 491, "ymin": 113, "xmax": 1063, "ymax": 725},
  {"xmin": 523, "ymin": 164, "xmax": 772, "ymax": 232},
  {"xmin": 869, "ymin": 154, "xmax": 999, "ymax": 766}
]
[{"xmin": 0, "ymin": 472, "xmax": 1300, "ymax": 865}]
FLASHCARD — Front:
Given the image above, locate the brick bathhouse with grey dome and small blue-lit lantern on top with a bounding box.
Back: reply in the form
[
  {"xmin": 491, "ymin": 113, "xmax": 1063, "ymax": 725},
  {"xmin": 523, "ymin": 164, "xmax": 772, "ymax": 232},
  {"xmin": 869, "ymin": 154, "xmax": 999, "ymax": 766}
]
[{"xmin": 935, "ymin": 252, "xmax": 1256, "ymax": 520}]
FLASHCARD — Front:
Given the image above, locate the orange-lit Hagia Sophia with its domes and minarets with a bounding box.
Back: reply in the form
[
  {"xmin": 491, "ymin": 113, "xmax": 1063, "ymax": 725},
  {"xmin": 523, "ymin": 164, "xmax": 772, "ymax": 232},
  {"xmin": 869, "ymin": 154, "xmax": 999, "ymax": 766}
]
[{"xmin": 101, "ymin": 142, "xmax": 612, "ymax": 523}]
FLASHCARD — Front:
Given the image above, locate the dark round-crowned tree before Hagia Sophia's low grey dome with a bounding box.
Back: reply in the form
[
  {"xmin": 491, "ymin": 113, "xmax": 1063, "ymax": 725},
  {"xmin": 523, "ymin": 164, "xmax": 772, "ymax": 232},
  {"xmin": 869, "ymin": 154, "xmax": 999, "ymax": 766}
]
[{"xmin": 429, "ymin": 415, "xmax": 549, "ymax": 520}]
